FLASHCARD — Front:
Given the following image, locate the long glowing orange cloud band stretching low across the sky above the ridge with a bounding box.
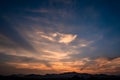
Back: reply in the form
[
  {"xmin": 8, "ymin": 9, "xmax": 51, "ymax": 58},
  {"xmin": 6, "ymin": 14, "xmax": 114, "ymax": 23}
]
[{"xmin": 3, "ymin": 58, "xmax": 120, "ymax": 74}]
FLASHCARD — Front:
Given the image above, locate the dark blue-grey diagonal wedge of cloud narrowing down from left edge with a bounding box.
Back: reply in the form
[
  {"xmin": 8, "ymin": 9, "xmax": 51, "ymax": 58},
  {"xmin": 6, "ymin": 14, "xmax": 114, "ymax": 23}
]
[{"xmin": 0, "ymin": 18, "xmax": 35, "ymax": 51}]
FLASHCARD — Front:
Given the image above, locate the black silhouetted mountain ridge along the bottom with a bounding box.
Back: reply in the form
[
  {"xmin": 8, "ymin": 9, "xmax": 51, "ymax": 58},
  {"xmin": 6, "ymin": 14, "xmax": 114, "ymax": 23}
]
[{"xmin": 0, "ymin": 72, "xmax": 120, "ymax": 80}]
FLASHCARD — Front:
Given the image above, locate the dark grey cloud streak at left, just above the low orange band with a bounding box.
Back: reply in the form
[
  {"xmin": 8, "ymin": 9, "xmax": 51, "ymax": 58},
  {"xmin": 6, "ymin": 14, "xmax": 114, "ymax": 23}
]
[{"xmin": 0, "ymin": 52, "xmax": 49, "ymax": 65}]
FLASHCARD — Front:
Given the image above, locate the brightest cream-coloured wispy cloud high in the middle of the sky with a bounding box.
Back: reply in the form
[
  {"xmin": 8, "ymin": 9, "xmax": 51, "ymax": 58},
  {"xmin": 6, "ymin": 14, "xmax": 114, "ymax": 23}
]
[{"xmin": 37, "ymin": 32, "xmax": 77, "ymax": 44}]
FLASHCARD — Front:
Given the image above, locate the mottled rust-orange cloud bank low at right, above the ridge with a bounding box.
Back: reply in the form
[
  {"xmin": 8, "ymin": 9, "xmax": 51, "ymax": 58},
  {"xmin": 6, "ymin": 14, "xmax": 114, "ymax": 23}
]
[{"xmin": 80, "ymin": 57, "xmax": 120, "ymax": 74}]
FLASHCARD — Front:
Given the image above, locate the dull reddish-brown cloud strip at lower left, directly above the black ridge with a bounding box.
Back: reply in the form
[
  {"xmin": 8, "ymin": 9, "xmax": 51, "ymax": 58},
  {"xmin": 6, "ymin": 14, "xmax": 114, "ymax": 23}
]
[{"xmin": 0, "ymin": 63, "xmax": 58, "ymax": 75}]
